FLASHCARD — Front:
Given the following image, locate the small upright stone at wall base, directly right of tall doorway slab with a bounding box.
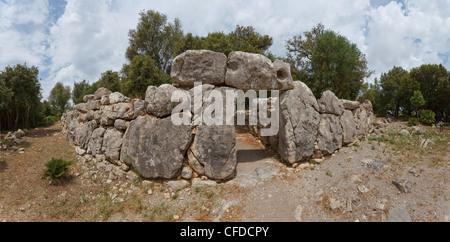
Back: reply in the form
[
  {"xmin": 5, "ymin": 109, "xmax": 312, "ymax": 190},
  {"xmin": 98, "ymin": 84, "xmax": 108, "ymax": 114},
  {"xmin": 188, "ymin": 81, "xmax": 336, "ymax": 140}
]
[{"xmin": 317, "ymin": 114, "xmax": 342, "ymax": 154}]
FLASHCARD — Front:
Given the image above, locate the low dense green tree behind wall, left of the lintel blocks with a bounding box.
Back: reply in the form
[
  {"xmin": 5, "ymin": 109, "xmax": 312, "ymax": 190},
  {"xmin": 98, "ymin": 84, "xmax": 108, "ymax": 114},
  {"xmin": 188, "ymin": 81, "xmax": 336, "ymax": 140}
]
[{"xmin": 121, "ymin": 55, "xmax": 170, "ymax": 99}]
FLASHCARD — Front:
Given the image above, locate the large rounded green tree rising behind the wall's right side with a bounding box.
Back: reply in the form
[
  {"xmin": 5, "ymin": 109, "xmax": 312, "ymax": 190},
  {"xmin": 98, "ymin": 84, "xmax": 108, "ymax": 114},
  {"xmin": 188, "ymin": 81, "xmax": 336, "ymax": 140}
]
[{"xmin": 286, "ymin": 24, "xmax": 372, "ymax": 100}]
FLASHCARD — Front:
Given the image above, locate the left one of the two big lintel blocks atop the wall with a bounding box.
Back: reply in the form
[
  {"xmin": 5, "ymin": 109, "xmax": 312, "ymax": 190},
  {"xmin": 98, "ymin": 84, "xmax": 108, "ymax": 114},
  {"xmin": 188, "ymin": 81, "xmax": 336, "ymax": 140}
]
[{"xmin": 171, "ymin": 50, "xmax": 227, "ymax": 87}]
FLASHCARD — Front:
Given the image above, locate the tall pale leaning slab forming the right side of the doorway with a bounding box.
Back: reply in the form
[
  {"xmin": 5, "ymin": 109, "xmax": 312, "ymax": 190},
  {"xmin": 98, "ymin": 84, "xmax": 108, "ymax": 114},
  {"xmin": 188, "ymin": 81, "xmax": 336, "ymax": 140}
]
[{"xmin": 278, "ymin": 81, "xmax": 321, "ymax": 164}]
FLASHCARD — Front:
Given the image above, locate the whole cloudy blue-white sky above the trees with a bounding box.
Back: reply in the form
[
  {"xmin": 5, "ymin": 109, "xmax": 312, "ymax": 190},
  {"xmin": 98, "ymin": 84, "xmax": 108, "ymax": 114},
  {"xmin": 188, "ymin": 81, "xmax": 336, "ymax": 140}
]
[{"xmin": 0, "ymin": 0, "xmax": 450, "ymax": 98}]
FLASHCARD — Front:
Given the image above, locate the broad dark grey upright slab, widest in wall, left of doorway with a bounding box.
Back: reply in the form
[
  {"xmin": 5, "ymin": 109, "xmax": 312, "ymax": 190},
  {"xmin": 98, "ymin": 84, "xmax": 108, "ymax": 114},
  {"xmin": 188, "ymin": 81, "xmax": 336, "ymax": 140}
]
[{"xmin": 121, "ymin": 116, "xmax": 192, "ymax": 179}]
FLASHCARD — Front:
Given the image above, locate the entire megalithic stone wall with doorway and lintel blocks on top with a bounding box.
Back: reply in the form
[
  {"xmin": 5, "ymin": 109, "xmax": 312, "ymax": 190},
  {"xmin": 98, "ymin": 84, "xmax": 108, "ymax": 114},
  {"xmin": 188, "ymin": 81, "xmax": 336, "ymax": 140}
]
[{"xmin": 61, "ymin": 50, "xmax": 374, "ymax": 180}]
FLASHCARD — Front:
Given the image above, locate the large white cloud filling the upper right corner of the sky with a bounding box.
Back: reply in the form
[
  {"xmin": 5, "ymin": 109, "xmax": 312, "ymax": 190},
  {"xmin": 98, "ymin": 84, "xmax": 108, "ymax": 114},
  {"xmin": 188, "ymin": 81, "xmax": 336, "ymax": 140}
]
[{"xmin": 366, "ymin": 1, "xmax": 450, "ymax": 80}]
